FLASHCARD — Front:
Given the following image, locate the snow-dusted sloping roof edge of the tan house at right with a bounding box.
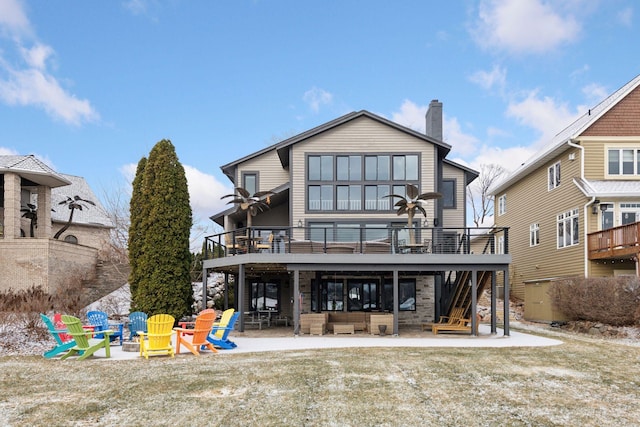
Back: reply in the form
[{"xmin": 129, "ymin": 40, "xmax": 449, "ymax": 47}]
[{"xmin": 489, "ymin": 75, "xmax": 640, "ymax": 195}]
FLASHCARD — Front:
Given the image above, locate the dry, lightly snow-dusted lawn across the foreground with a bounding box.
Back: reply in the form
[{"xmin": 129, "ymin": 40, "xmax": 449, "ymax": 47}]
[{"xmin": 0, "ymin": 335, "xmax": 640, "ymax": 426}]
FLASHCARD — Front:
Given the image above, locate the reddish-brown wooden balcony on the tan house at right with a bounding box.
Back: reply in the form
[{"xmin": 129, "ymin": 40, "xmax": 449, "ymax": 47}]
[{"xmin": 587, "ymin": 222, "xmax": 640, "ymax": 260}]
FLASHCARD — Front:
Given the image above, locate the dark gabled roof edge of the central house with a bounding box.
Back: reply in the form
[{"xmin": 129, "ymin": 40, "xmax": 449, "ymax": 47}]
[{"xmin": 220, "ymin": 110, "xmax": 452, "ymax": 182}]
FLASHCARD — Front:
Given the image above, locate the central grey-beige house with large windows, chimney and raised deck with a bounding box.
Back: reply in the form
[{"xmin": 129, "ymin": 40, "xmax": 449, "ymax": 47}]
[{"xmin": 204, "ymin": 101, "xmax": 510, "ymax": 333}]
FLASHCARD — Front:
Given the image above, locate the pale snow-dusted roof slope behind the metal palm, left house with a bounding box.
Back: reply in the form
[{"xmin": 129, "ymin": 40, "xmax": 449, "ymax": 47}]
[{"xmin": 51, "ymin": 174, "xmax": 114, "ymax": 228}]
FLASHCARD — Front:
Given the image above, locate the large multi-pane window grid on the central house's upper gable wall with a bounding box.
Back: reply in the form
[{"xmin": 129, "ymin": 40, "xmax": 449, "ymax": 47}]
[{"xmin": 307, "ymin": 154, "xmax": 418, "ymax": 212}]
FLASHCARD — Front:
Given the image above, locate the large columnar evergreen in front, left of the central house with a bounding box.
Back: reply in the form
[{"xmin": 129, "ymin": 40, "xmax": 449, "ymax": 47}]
[{"xmin": 132, "ymin": 140, "xmax": 193, "ymax": 319}]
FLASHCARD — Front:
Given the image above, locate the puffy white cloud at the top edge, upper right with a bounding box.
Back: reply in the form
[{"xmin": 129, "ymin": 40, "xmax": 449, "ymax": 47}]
[{"xmin": 472, "ymin": 0, "xmax": 581, "ymax": 53}]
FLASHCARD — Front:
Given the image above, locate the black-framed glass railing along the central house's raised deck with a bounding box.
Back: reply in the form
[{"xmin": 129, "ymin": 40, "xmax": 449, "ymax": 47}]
[{"xmin": 204, "ymin": 226, "xmax": 509, "ymax": 259}]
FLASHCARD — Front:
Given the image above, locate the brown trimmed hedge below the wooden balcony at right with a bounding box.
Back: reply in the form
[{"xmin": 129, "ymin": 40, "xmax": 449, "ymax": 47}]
[{"xmin": 549, "ymin": 277, "xmax": 640, "ymax": 326}]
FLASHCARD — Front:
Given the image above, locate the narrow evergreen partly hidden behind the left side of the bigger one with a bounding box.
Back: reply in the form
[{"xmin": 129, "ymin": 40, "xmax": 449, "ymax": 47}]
[{"xmin": 127, "ymin": 157, "xmax": 149, "ymax": 304}]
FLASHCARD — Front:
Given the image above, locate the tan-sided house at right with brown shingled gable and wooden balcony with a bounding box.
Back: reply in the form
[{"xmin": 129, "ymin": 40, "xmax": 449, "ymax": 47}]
[{"xmin": 490, "ymin": 72, "xmax": 640, "ymax": 321}]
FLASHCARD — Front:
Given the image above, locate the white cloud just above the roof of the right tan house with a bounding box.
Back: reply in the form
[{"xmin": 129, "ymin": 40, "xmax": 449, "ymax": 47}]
[{"xmin": 507, "ymin": 90, "xmax": 579, "ymax": 147}]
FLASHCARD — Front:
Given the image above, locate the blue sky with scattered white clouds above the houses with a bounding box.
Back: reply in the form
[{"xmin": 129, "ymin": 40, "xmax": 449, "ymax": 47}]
[{"xmin": 0, "ymin": 0, "xmax": 640, "ymax": 244}]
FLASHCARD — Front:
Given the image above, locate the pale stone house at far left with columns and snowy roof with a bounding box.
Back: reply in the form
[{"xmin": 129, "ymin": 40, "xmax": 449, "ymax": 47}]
[{"xmin": 0, "ymin": 155, "xmax": 115, "ymax": 298}]
